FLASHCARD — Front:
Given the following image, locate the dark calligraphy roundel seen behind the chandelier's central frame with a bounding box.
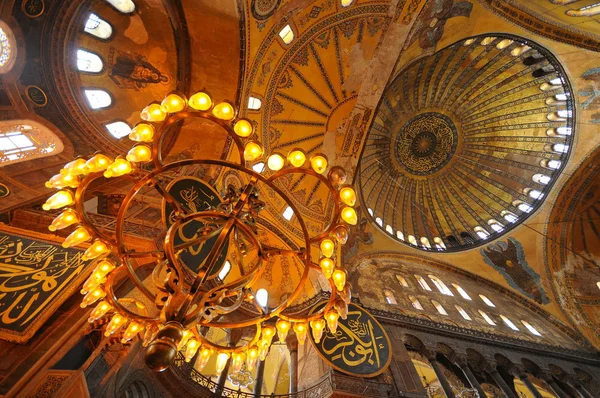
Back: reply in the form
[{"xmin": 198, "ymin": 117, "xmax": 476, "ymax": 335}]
[{"xmin": 163, "ymin": 177, "xmax": 229, "ymax": 276}]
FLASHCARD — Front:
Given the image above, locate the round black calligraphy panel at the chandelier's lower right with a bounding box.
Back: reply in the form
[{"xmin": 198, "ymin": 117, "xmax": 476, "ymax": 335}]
[{"xmin": 310, "ymin": 303, "xmax": 392, "ymax": 377}]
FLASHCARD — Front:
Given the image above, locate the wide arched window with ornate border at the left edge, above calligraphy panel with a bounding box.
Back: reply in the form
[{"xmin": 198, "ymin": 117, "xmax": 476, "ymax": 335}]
[{"xmin": 0, "ymin": 120, "xmax": 64, "ymax": 166}]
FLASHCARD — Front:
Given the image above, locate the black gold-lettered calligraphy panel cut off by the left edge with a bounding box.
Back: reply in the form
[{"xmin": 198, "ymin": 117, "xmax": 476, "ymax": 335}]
[{"xmin": 0, "ymin": 231, "xmax": 89, "ymax": 343}]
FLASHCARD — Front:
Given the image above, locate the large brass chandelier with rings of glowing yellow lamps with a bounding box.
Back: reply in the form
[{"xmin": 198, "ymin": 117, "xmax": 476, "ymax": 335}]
[{"xmin": 43, "ymin": 92, "xmax": 357, "ymax": 373}]
